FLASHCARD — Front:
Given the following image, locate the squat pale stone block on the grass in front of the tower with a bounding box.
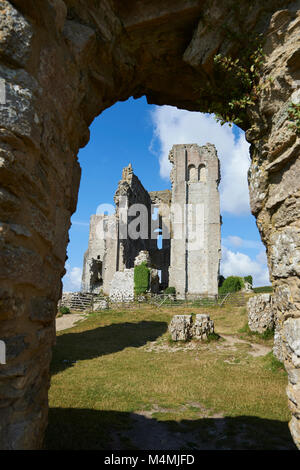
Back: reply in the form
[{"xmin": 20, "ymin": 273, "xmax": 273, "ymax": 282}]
[{"xmin": 169, "ymin": 314, "xmax": 214, "ymax": 341}]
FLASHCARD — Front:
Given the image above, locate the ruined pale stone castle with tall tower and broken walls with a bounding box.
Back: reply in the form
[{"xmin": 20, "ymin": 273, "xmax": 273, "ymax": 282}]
[{"xmin": 82, "ymin": 144, "xmax": 221, "ymax": 297}]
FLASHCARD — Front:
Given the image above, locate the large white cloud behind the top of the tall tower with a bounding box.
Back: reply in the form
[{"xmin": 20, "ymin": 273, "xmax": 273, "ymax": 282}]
[{"xmin": 150, "ymin": 106, "xmax": 250, "ymax": 215}]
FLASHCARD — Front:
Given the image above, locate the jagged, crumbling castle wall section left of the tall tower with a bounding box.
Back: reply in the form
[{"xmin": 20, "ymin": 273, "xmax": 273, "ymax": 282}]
[{"xmin": 82, "ymin": 164, "xmax": 157, "ymax": 295}]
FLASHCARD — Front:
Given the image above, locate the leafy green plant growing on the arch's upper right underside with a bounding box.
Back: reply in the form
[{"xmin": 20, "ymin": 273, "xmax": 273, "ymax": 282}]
[{"xmin": 196, "ymin": 25, "xmax": 271, "ymax": 129}]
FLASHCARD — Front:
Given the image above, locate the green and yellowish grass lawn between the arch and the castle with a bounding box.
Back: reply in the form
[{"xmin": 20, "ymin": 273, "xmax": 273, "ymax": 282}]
[{"xmin": 45, "ymin": 306, "xmax": 294, "ymax": 450}]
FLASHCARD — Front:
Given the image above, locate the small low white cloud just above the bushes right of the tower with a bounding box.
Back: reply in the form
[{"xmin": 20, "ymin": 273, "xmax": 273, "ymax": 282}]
[{"xmin": 220, "ymin": 246, "xmax": 270, "ymax": 286}]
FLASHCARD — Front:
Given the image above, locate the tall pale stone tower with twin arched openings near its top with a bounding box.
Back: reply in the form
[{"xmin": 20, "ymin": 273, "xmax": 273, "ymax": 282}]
[{"xmin": 169, "ymin": 144, "xmax": 221, "ymax": 296}]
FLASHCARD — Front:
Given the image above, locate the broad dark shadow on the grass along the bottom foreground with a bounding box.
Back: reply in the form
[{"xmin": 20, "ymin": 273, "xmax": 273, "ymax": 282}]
[{"xmin": 45, "ymin": 408, "xmax": 296, "ymax": 450}]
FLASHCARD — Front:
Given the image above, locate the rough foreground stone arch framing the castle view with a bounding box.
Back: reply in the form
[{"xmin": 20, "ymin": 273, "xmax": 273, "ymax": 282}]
[{"xmin": 0, "ymin": 0, "xmax": 300, "ymax": 449}]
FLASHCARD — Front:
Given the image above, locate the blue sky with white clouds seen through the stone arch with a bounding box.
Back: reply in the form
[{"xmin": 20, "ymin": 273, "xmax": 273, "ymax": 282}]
[{"xmin": 63, "ymin": 98, "xmax": 269, "ymax": 291}]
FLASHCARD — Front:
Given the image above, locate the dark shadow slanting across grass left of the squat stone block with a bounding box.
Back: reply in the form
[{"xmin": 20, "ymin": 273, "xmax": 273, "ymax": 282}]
[{"xmin": 51, "ymin": 321, "xmax": 168, "ymax": 374}]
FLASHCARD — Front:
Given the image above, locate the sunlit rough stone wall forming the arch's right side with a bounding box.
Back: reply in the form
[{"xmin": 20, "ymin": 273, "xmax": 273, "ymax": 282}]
[{"xmin": 246, "ymin": 2, "xmax": 300, "ymax": 447}]
